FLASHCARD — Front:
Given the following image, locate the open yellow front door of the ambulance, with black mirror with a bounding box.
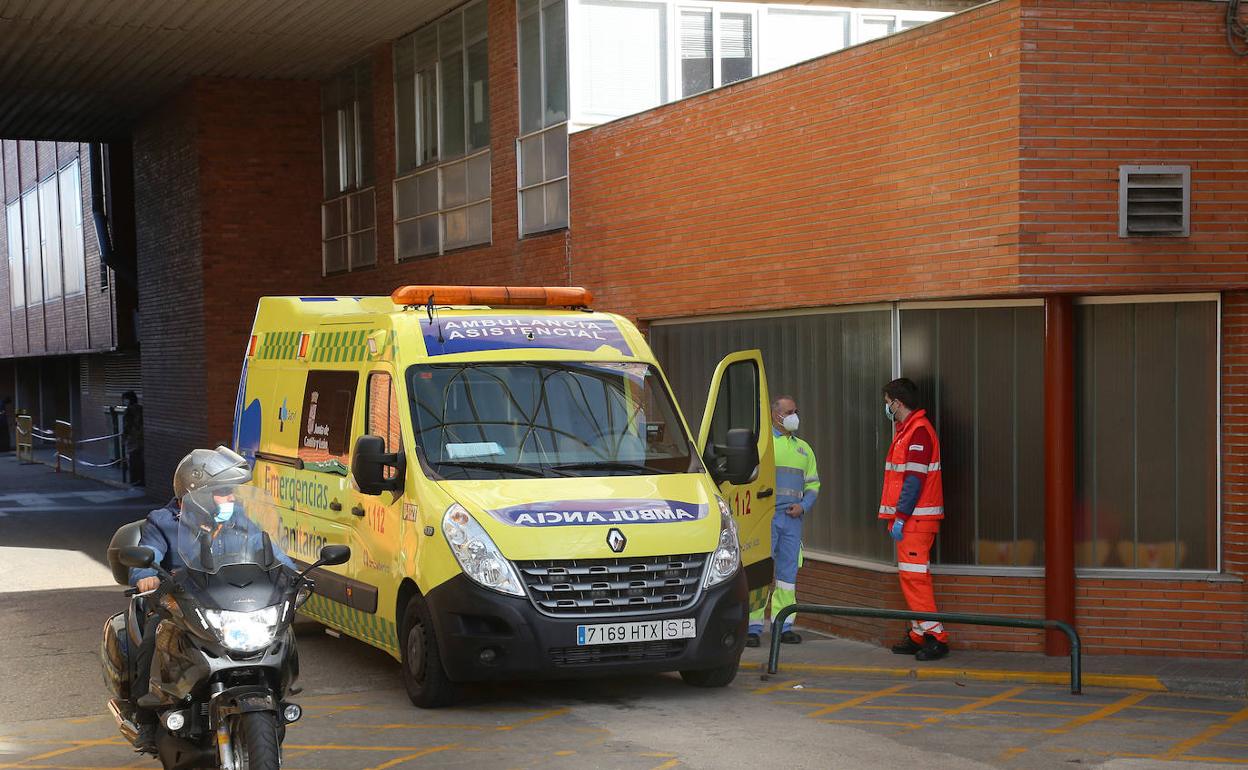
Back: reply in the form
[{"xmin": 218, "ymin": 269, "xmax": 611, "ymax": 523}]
[{"xmin": 698, "ymin": 351, "xmax": 776, "ymax": 610}]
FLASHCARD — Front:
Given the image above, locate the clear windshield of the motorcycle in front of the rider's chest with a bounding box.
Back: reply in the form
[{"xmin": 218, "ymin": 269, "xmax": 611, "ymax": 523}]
[{"xmin": 177, "ymin": 485, "xmax": 277, "ymax": 574}]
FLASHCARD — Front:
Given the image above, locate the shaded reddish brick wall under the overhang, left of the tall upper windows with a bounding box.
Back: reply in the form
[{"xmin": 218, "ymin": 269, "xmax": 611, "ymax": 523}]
[{"xmin": 193, "ymin": 80, "xmax": 321, "ymax": 442}]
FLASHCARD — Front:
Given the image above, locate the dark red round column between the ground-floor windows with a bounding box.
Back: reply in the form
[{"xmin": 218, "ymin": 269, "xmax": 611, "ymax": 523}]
[{"xmin": 1045, "ymin": 296, "xmax": 1075, "ymax": 655}]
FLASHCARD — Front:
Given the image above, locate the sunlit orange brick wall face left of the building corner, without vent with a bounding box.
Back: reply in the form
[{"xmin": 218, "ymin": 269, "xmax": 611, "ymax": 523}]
[{"xmin": 570, "ymin": 2, "xmax": 1020, "ymax": 318}]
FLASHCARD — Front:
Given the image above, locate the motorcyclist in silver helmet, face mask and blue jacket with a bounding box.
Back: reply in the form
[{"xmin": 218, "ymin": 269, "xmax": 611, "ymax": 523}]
[{"xmin": 130, "ymin": 447, "xmax": 296, "ymax": 753}]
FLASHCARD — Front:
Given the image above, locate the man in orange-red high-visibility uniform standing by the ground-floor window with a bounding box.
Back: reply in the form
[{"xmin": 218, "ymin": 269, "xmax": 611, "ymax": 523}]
[{"xmin": 880, "ymin": 377, "xmax": 948, "ymax": 660}]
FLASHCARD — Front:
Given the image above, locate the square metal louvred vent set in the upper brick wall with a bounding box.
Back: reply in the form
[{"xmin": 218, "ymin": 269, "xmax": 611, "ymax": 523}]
[{"xmin": 1118, "ymin": 166, "xmax": 1192, "ymax": 238}]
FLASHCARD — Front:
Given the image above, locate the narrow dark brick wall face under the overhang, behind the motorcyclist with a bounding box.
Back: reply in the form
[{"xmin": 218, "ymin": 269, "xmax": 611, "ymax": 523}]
[{"xmin": 134, "ymin": 91, "xmax": 205, "ymax": 497}]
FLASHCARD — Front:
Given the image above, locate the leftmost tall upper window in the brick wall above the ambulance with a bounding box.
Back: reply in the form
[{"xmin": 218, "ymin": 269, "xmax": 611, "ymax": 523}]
[{"xmin": 321, "ymin": 60, "xmax": 377, "ymax": 275}]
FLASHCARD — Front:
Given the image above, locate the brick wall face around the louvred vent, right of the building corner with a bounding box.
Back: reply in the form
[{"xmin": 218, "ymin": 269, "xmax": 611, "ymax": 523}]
[{"xmin": 1017, "ymin": 0, "xmax": 1248, "ymax": 292}]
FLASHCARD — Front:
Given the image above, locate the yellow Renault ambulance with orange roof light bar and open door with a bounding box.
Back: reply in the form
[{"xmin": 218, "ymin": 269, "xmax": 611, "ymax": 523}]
[{"xmin": 233, "ymin": 286, "xmax": 775, "ymax": 708}]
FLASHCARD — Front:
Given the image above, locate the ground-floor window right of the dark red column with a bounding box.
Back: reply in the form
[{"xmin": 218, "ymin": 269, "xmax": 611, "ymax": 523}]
[{"xmin": 1075, "ymin": 298, "xmax": 1218, "ymax": 570}]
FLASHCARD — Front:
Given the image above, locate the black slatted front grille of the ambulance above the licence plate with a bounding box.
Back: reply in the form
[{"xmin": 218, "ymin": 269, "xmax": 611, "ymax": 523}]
[{"xmin": 515, "ymin": 553, "xmax": 708, "ymax": 618}]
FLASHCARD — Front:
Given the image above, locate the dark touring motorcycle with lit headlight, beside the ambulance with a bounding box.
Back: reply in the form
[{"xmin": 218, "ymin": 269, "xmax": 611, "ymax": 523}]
[{"xmin": 100, "ymin": 487, "xmax": 351, "ymax": 770}]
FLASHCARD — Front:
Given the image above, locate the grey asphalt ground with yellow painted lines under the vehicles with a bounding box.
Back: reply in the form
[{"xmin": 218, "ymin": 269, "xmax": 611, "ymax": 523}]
[{"xmin": 0, "ymin": 456, "xmax": 1248, "ymax": 770}]
